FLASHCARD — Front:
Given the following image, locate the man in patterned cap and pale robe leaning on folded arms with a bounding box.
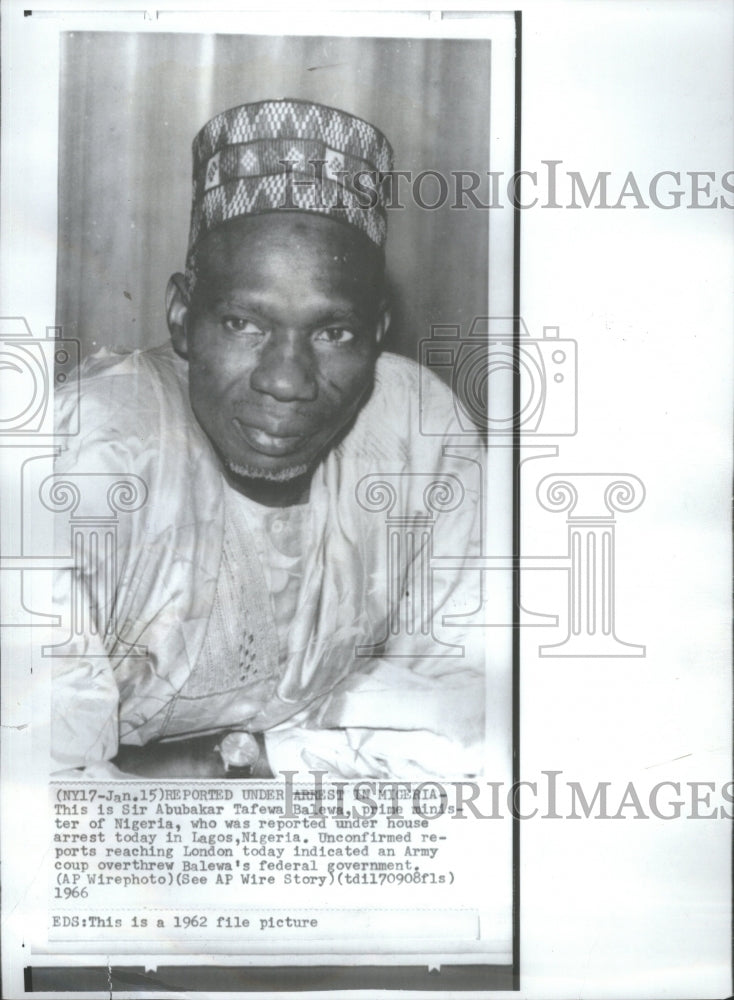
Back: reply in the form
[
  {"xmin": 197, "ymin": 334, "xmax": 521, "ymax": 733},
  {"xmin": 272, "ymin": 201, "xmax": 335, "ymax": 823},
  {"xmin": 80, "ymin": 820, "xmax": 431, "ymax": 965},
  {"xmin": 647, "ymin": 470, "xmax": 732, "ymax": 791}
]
[{"xmin": 52, "ymin": 100, "xmax": 484, "ymax": 777}]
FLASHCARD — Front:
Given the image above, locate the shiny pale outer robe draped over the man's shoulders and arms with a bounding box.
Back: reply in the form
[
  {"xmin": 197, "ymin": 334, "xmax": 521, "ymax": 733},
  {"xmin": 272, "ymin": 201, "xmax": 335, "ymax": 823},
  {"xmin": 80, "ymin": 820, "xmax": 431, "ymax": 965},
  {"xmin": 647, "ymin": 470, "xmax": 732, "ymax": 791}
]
[{"xmin": 52, "ymin": 346, "xmax": 486, "ymax": 777}]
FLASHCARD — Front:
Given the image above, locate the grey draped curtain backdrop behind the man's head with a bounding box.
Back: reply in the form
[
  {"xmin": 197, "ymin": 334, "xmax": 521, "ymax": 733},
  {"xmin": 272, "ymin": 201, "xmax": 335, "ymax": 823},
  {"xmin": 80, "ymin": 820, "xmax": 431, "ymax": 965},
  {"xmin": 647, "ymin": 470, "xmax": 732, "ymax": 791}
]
[{"xmin": 57, "ymin": 31, "xmax": 490, "ymax": 368}]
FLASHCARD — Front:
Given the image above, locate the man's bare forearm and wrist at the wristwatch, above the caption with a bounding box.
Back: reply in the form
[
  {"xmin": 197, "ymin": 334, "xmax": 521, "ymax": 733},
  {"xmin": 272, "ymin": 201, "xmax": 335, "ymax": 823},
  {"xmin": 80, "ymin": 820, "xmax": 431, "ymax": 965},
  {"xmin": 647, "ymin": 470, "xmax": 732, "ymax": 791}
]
[{"xmin": 112, "ymin": 733, "xmax": 273, "ymax": 779}]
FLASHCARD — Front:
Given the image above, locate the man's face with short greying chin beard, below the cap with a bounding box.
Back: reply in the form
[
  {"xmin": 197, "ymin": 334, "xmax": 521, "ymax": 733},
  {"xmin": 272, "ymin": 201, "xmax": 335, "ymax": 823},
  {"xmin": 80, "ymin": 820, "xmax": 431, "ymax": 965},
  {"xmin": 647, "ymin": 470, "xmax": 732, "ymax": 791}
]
[{"xmin": 169, "ymin": 213, "xmax": 387, "ymax": 482}]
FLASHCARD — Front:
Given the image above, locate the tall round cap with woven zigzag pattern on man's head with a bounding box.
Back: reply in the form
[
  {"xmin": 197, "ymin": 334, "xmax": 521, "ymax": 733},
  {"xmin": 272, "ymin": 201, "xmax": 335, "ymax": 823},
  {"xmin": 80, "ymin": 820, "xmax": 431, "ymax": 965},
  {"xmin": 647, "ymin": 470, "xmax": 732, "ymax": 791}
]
[{"xmin": 189, "ymin": 99, "xmax": 392, "ymax": 262}]
